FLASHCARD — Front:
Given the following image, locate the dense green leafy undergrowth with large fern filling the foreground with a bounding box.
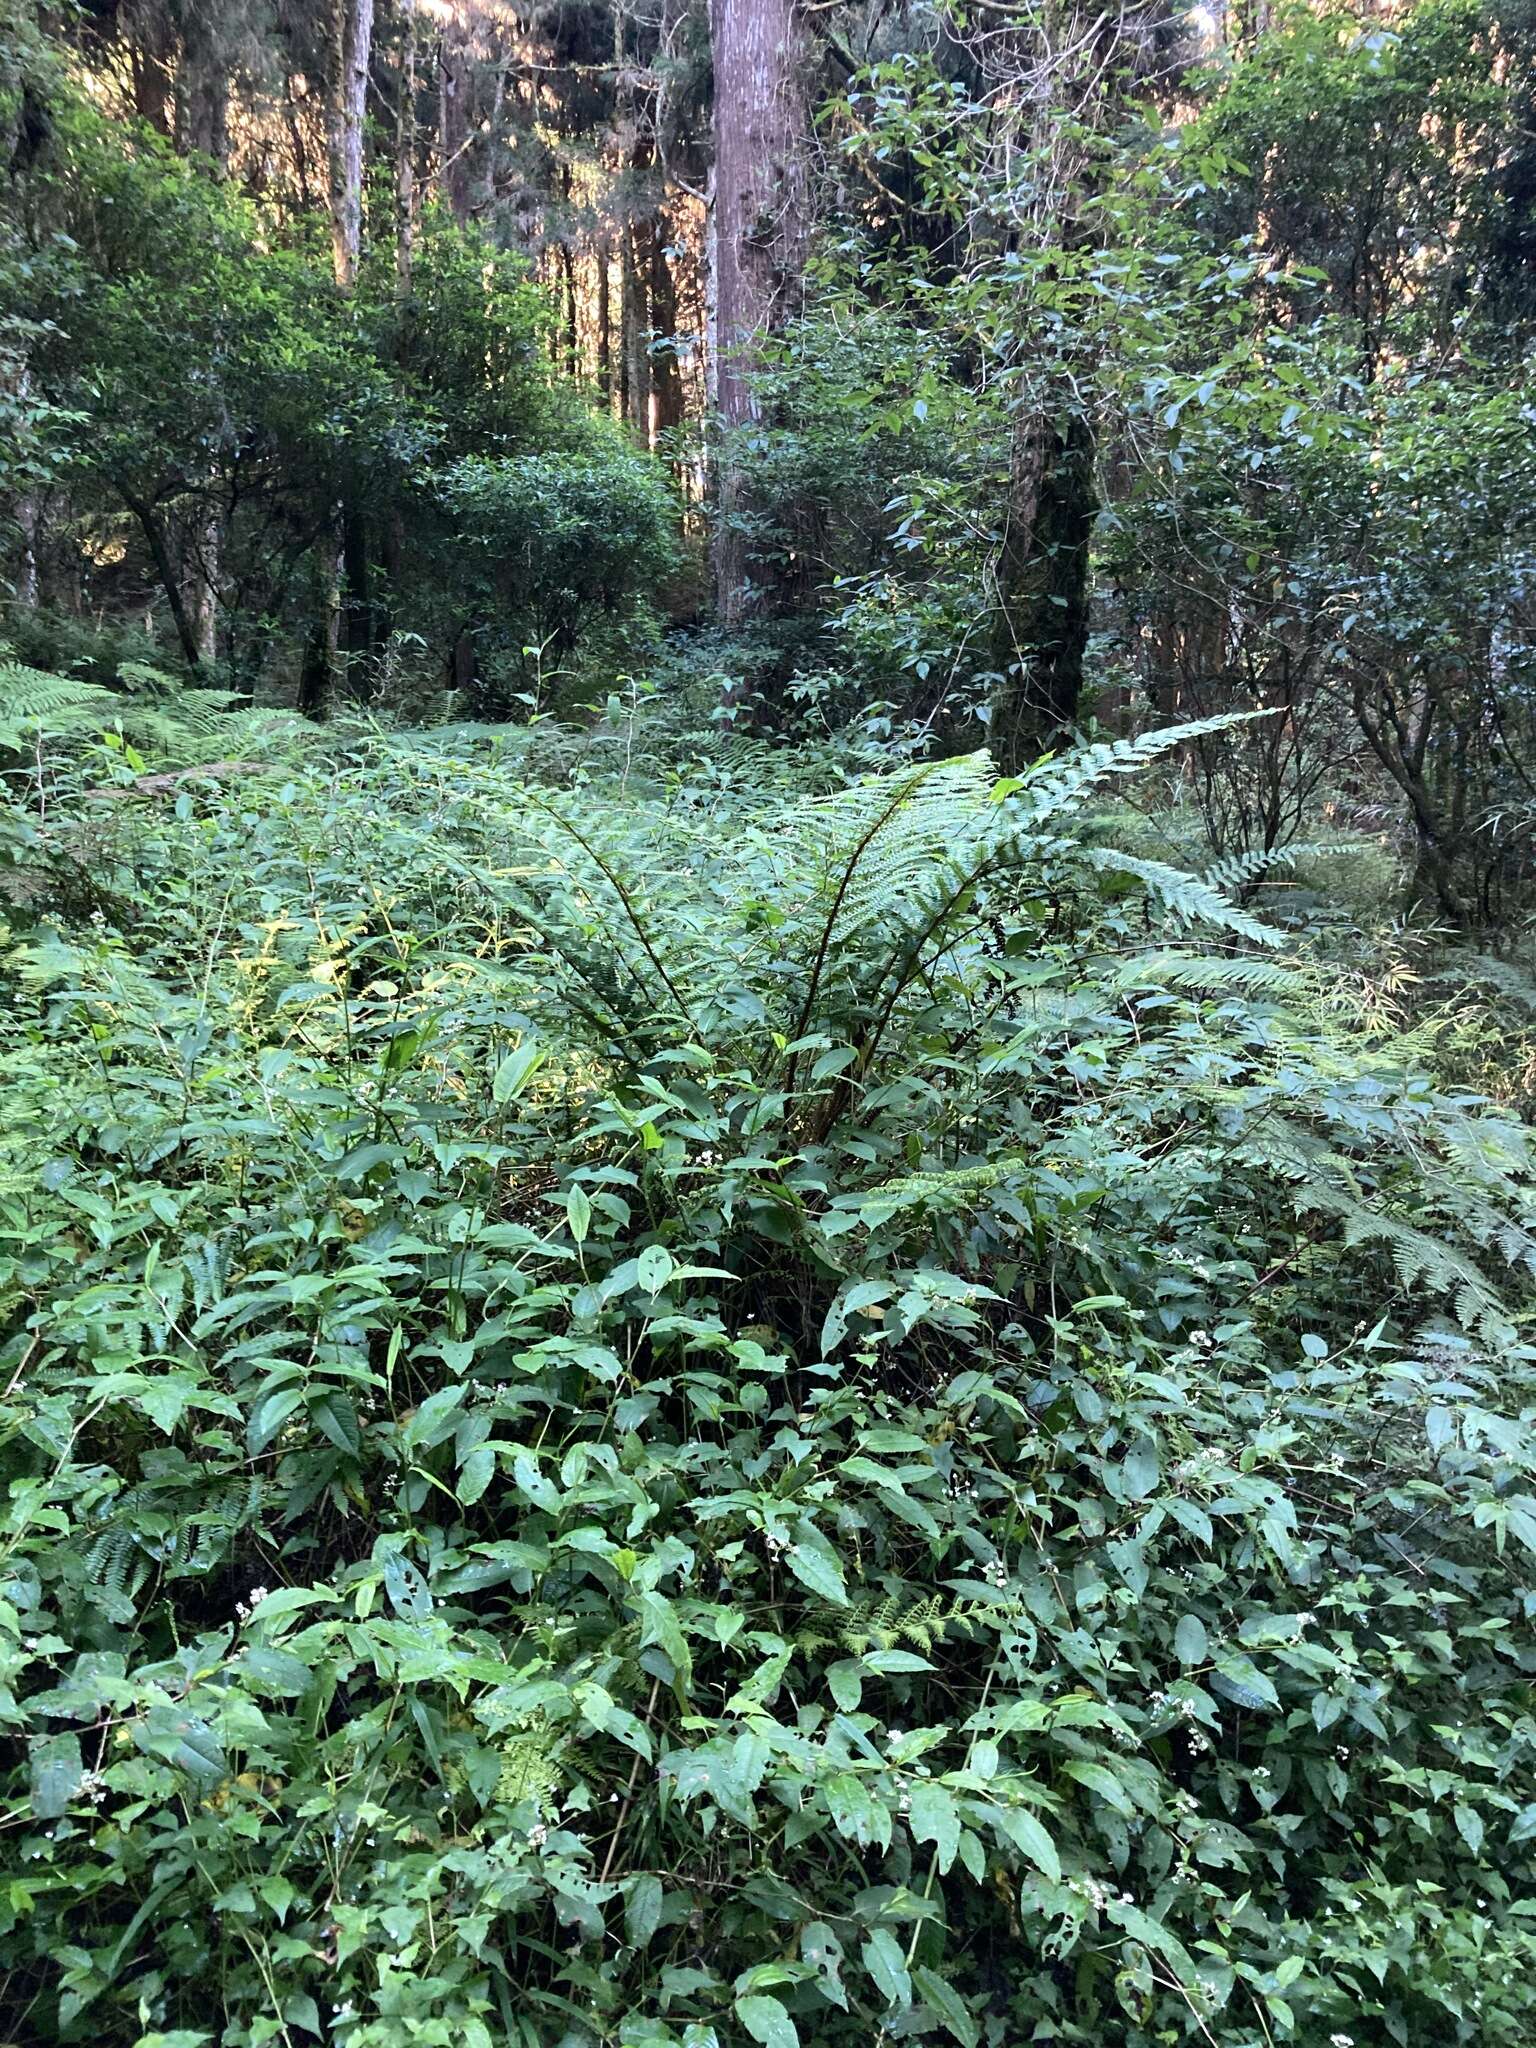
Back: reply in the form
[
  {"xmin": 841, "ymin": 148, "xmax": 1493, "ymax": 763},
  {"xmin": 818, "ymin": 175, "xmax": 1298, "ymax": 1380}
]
[{"xmin": 0, "ymin": 735, "xmax": 1536, "ymax": 2048}]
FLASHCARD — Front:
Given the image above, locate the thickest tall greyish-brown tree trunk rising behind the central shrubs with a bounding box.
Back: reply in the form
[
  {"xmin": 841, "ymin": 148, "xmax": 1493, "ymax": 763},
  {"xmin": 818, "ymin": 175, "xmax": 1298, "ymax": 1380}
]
[{"xmin": 709, "ymin": 0, "xmax": 811, "ymax": 625}]
